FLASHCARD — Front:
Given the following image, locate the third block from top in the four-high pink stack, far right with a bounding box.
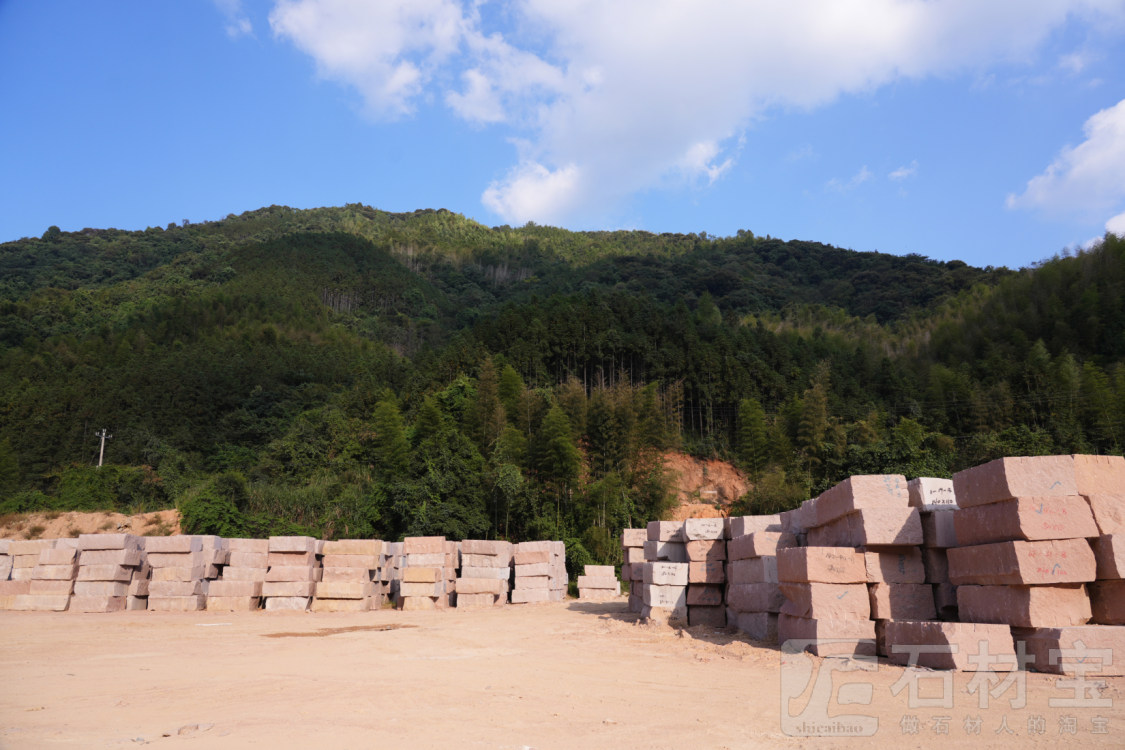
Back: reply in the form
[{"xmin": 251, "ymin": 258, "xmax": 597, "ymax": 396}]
[{"xmin": 948, "ymin": 539, "xmax": 1097, "ymax": 586}]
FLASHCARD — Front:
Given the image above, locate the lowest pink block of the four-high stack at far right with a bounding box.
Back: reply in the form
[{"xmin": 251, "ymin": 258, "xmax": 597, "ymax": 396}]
[{"xmin": 957, "ymin": 584, "xmax": 1091, "ymax": 627}]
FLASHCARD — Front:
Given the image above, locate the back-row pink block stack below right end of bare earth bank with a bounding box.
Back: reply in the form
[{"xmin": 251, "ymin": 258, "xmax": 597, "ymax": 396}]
[{"xmin": 144, "ymin": 535, "xmax": 228, "ymax": 612}]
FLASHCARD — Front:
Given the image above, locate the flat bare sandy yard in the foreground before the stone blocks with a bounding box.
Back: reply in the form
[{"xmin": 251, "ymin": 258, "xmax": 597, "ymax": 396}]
[{"xmin": 0, "ymin": 599, "xmax": 1125, "ymax": 750}]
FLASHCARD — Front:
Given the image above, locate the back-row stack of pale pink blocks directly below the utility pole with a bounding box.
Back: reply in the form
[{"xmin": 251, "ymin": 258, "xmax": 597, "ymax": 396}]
[{"xmin": 72, "ymin": 534, "xmax": 149, "ymax": 612}]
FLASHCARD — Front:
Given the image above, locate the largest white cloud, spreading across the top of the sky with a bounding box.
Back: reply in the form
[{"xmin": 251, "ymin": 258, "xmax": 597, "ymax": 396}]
[{"xmin": 263, "ymin": 0, "xmax": 1125, "ymax": 226}]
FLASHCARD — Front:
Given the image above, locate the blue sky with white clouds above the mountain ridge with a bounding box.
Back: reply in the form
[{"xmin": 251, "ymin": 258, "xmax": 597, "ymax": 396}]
[{"xmin": 0, "ymin": 0, "xmax": 1125, "ymax": 268}]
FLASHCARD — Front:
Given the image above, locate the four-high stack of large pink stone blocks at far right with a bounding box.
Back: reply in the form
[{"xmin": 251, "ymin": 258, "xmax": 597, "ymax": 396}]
[{"xmin": 948, "ymin": 455, "xmax": 1098, "ymax": 627}]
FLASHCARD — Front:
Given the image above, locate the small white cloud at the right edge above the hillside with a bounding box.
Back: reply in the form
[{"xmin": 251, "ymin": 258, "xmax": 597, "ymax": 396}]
[{"xmin": 1007, "ymin": 99, "xmax": 1125, "ymax": 226}]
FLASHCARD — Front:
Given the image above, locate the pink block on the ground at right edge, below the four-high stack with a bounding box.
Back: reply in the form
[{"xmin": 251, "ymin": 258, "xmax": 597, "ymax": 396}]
[{"xmin": 1011, "ymin": 625, "xmax": 1125, "ymax": 677}]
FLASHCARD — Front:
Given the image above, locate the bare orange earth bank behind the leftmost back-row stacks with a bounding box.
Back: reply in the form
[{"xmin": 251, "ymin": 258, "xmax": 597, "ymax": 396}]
[{"xmin": 0, "ymin": 510, "xmax": 180, "ymax": 539}]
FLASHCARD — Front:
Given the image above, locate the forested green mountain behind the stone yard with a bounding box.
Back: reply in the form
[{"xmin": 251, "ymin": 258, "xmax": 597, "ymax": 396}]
[{"xmin": 0, "ymin": 206, "xmax": 1125, "ymax": 564}]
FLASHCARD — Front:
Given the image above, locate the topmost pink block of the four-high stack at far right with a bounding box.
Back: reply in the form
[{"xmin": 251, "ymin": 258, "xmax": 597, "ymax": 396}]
[{"xmin": 953, "ymin": 455, "xmax": 1079, "ymax": 508}]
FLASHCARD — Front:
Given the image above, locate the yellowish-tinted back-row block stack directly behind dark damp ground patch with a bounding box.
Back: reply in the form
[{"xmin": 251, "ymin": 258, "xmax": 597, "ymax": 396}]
[{"xmin": 313, "ymin": 539, "xmax": 385, "ymax": 612}]
